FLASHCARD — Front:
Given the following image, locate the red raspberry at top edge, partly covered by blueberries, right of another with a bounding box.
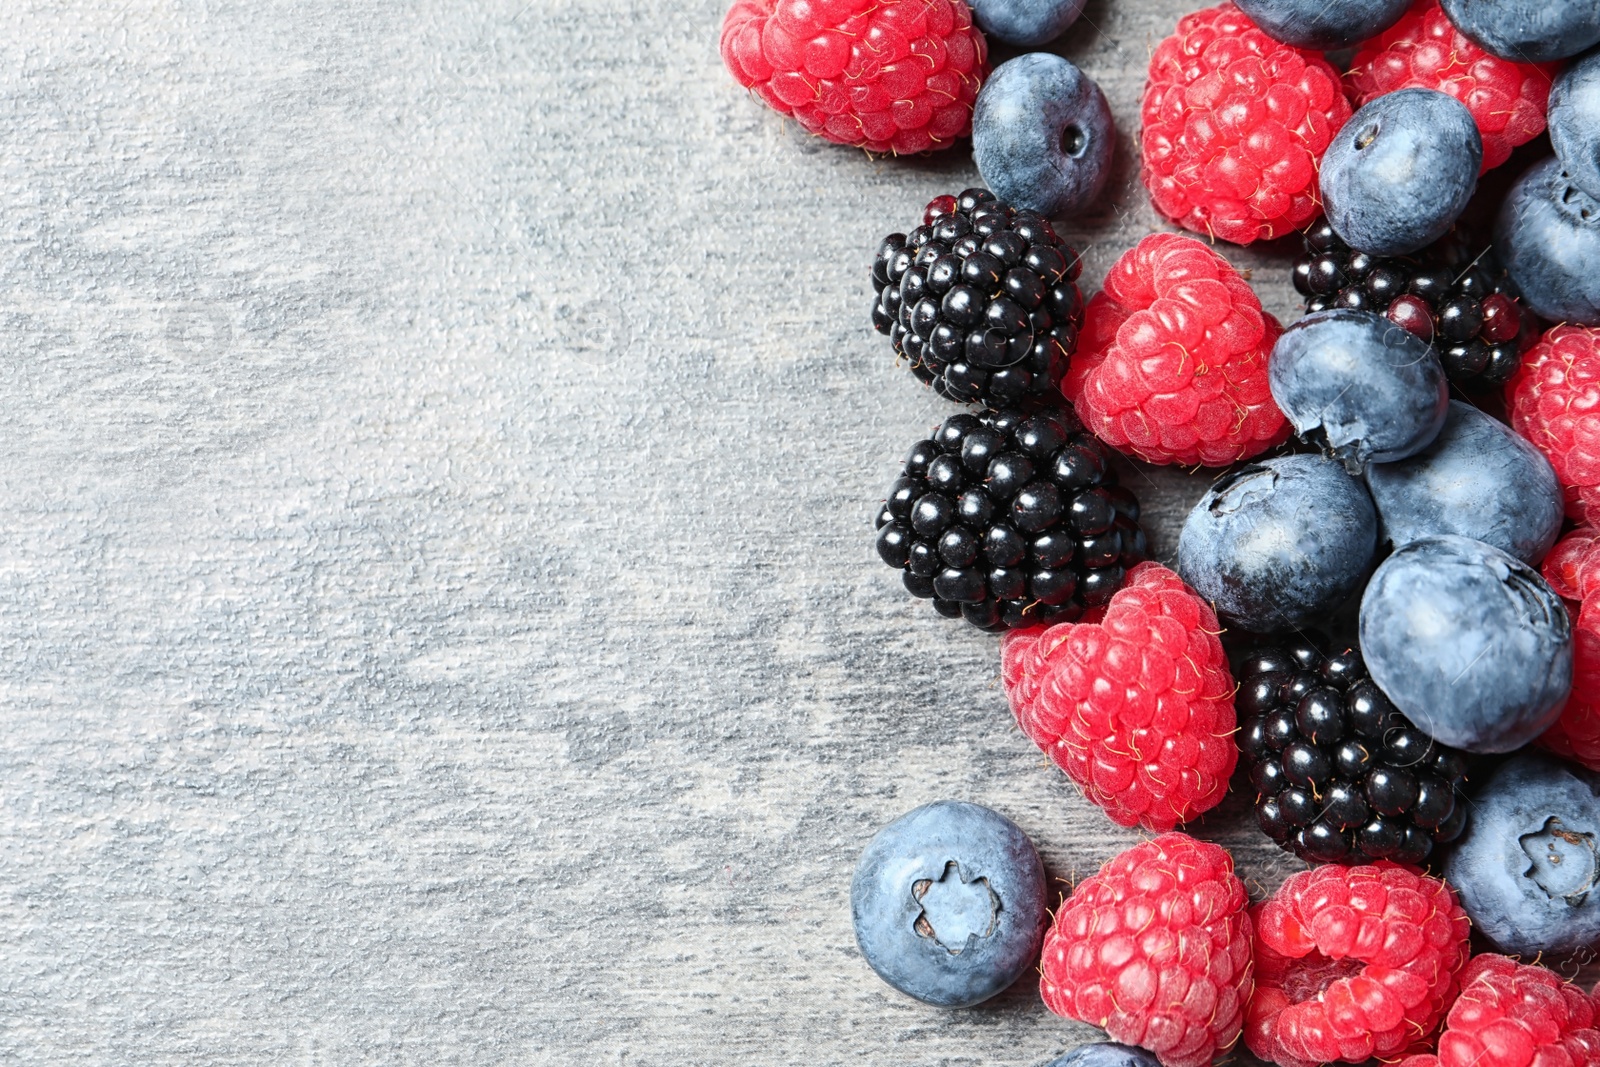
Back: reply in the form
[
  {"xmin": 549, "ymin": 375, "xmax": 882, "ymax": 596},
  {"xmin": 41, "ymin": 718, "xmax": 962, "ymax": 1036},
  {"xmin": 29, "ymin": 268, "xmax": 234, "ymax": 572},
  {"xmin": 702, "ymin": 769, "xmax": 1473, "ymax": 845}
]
[{"xmin": 1344, "ymin": 0, "xmax": 1558, "ymax": 171}]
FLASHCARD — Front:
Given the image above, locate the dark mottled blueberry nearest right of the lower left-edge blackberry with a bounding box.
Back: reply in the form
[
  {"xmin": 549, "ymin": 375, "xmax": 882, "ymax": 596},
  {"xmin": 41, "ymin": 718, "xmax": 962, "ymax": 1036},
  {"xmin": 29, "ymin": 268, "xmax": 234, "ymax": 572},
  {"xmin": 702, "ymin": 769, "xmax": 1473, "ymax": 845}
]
[{"xmin": 1178, "ymin": 456, "xmax": 1378, "ymax": 633}]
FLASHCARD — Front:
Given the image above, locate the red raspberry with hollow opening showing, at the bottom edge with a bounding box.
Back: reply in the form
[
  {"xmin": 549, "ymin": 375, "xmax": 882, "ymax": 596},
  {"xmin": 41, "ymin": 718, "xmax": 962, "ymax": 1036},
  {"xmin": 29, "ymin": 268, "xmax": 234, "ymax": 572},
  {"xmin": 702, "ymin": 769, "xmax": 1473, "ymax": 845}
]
[{"xmin": 1245, "ymin": 862, "xmax": 1469, "ymax": 1067}]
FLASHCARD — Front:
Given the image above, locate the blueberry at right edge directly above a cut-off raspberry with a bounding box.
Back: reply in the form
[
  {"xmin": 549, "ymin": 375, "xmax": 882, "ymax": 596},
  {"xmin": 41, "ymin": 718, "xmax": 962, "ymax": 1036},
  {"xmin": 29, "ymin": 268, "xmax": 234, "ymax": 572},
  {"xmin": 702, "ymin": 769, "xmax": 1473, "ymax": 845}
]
[{"xmin": 1494, "ymin": 157, "xmax": 1600, "ymax": 326}]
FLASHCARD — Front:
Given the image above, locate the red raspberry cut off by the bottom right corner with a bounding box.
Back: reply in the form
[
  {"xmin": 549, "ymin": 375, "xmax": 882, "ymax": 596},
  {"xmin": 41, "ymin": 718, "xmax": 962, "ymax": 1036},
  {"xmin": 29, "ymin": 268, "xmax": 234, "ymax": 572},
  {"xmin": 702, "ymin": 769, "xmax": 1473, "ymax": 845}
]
[{"xmin": 1400, "ymin": 953, "xmax": 1600, "ymax": 1067}]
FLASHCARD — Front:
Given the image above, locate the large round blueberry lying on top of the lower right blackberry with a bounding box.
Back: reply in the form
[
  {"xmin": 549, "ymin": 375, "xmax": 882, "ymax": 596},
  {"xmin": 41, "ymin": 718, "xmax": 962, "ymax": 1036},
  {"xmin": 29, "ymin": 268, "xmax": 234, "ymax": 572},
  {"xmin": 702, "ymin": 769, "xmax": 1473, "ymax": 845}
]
[{"xmin": 1360, "ymin": 536, "xmax": 1573, "ymax": 752}]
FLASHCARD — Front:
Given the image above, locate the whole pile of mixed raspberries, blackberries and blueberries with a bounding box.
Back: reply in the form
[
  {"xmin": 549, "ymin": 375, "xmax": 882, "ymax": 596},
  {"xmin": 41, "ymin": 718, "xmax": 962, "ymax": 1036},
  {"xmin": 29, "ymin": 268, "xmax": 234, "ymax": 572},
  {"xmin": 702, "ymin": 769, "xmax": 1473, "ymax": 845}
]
[{"xmin": 722, "ymin": 0, "xmax": 1600, "ymax": 1067}]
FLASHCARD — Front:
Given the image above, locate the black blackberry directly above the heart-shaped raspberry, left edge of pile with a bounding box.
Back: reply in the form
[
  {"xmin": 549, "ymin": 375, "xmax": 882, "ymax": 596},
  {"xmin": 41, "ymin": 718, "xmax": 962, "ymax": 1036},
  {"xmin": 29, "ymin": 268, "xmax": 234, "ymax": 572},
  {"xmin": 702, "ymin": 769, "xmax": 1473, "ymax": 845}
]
[{"xmin": 877, "ymin": 410, "xmax": 1149, "ymax": 632}]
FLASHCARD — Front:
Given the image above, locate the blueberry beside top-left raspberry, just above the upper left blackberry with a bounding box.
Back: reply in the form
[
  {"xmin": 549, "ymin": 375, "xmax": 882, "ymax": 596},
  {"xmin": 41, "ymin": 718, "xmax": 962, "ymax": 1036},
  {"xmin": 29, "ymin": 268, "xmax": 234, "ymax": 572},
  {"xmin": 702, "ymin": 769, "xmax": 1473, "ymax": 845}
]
[{"xmin": 973, "ymin": 51, "xmax": 1117, "ymax": 216}]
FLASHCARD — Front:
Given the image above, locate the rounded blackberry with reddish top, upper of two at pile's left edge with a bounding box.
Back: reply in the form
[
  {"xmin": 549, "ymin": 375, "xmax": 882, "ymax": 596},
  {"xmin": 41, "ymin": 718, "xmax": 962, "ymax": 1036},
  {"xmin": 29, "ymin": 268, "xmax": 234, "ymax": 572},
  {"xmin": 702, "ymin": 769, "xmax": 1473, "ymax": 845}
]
[{"xmin": 872, "ymin": 189, "xmax": 1083, "ymax": 410}]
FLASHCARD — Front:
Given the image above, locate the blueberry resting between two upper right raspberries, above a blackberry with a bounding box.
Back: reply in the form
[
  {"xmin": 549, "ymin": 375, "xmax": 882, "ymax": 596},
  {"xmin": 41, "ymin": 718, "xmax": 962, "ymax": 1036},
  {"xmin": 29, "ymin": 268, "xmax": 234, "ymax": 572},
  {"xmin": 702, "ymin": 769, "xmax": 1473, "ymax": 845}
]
[{"xmin": 1320, "ymin": 90, "xmax": 1483, "ymax": 256}]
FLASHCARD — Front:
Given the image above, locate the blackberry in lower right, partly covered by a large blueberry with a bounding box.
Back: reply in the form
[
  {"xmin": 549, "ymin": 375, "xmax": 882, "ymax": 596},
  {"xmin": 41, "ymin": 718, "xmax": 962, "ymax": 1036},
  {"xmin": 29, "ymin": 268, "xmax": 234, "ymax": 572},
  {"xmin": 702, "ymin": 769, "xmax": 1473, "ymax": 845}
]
[{"xmin": 1234, "ymin": 637, "xmax": 1467, "ymax": 865}]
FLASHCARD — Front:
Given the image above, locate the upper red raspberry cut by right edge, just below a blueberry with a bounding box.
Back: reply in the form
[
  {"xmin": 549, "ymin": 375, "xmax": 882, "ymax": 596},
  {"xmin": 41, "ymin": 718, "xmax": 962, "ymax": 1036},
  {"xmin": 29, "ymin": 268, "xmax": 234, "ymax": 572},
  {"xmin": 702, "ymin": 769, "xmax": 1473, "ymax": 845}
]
[{"xmin": 1506, "ymin": 326, "xmax": 1600, "ymax": 525}]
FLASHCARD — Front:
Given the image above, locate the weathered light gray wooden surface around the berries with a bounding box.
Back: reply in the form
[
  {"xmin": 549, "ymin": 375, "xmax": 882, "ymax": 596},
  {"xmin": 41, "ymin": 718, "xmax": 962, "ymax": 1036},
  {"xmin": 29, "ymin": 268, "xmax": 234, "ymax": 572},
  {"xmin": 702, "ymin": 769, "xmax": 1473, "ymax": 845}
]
[{"xmin": 0, "ymin": 0, "xmax": 1324, "ymax": 1067}]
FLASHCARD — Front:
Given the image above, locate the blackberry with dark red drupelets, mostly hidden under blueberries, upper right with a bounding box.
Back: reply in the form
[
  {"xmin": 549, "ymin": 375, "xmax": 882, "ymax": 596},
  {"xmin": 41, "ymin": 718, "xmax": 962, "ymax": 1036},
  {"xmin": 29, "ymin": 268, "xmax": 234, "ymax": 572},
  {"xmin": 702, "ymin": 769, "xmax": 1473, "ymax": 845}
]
[{"xmin": 1294, "ymin": 219, "xmax": 1539, "ymax": 392}]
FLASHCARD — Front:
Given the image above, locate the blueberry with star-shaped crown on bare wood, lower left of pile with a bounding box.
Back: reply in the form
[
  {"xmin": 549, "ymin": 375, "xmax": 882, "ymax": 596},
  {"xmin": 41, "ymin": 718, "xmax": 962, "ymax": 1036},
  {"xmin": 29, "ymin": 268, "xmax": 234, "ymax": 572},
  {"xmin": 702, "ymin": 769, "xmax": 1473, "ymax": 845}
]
[{"xmin": 850, "ymin": 800, "xmax": 1046, "ymax": 1008}]
